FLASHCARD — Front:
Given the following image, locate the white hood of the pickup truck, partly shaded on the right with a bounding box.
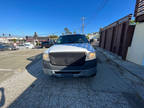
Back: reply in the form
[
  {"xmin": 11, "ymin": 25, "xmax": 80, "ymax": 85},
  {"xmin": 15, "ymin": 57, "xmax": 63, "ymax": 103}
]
[{"xmin": 45, "ymin": 43, "xmax": 95, "ymax": 53}]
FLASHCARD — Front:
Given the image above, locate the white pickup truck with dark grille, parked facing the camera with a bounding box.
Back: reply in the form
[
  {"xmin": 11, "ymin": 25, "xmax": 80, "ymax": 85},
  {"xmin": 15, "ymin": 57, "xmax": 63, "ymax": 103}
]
[{"xmin": 43, "ymin": 35, "xmax": 97, "ymax": 77}]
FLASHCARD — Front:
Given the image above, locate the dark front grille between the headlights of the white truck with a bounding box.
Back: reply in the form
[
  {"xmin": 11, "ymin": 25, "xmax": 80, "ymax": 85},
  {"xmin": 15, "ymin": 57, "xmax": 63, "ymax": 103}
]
[{"xmin": 49, "ymin": 52, "xmax": 86, "ymax": 66}]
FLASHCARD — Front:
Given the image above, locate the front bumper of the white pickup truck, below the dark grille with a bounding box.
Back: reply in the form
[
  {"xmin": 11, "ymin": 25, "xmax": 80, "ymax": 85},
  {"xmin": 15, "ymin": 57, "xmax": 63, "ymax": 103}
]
[{"xmin": 43, "ymin": 59, "xmax": 97, "ymax": 77}]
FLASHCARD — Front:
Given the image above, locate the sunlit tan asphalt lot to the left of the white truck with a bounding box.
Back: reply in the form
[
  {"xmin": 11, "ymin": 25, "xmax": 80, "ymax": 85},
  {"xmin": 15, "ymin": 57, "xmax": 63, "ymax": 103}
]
[{"xmin": 0, "ymin": 49, "xmax": 44, "ymax": 81}]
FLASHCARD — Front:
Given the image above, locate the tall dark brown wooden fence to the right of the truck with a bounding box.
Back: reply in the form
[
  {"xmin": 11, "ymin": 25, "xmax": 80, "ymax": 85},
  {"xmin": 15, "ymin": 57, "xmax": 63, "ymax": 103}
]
[{"xmin": 99, "ymin": 14, "xmax": 135, "ymax": 60}]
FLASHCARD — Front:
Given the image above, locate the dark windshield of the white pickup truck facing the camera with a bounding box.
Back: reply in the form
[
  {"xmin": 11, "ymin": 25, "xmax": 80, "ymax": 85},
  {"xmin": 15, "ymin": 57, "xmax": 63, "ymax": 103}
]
[{"xmin": 56, "ymin": 35, "xmax": 88, "ymax": 44}]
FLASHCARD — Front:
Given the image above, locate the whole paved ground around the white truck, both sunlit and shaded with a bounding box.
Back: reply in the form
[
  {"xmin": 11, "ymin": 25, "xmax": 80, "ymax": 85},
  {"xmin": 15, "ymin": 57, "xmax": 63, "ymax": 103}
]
[{"xmin": 0, "ymin": 50, "xmax": 143, "ymax": 108}]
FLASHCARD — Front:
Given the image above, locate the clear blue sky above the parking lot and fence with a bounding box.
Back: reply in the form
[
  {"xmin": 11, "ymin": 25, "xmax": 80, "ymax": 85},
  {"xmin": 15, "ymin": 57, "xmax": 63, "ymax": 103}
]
[{"xmin": 0, "ymin": 0, "xmax": 136, "ymax": 36}]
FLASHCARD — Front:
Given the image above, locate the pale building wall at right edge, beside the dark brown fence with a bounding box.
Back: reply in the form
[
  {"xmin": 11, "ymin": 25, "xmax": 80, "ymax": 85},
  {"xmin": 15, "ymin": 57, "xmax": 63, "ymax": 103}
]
[{"xmin": 127, "ymin": 23, "xmax": 144, "ymax": 65}]
